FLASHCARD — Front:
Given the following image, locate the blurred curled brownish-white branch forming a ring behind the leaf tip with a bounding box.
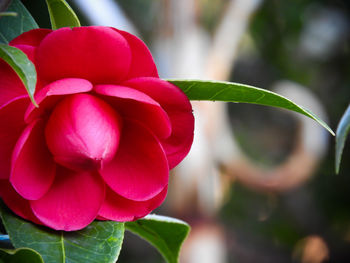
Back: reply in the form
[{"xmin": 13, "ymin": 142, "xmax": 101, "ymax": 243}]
[{"xmin": 224, "ymin": 81, "xmax": 329, "ymax": 192}]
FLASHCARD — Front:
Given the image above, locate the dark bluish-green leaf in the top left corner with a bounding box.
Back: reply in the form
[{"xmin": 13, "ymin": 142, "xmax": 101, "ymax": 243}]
[{"xmin": 0, "ymin": 0, "xmax": 38, "ymax": 44}]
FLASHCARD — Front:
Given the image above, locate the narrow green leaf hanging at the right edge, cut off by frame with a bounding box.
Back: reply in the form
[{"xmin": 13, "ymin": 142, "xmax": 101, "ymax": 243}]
[{"xmin": 335, "ymin": 105, "xmax": 350, "ymax": 174}]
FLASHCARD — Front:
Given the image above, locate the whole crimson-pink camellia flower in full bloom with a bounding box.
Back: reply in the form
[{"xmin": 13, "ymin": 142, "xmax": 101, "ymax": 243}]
[{"xmin": 0, "ymin": 26, "xmax": 194, "ymax": 231}]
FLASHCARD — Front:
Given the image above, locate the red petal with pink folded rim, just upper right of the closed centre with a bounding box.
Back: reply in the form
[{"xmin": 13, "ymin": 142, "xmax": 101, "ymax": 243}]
[{"xmin": 94, "ymin": 85, "xmax": 171, "ymax": 138}]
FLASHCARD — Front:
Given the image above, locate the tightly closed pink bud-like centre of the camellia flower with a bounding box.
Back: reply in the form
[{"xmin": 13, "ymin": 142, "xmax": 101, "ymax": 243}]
[{"xmin": 45, "ymin": 94, "xmax": 121, "ymax": 170}]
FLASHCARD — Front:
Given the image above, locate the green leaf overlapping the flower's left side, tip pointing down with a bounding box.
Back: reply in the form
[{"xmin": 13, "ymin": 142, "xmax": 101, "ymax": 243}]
[{"xmin": 0, "ymin": 44, "xmax": 38, "ymax": 107}]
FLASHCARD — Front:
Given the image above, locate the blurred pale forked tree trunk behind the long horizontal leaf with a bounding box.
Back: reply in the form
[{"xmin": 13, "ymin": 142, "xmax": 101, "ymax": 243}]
[{"xmin": 159, "ymin": 0, "xmax": 262, "ymax": 263}]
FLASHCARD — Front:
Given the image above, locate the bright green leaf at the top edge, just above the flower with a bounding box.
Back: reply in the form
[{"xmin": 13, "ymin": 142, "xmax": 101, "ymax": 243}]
[{"xmin": 46, "ymin": 0, "xmax": 80, "ymax": 29}]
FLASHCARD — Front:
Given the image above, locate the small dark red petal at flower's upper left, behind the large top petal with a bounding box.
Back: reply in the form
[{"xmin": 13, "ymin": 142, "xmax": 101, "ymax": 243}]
[{"xmin": 9, "ymin": 28, "xmax": 52, "ymax": 47}]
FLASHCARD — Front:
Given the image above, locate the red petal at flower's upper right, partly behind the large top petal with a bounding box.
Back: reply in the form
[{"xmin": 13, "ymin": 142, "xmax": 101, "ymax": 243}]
[{"xmin": 113, "ymin": 28, "xmax": 158, "ymax": 79}]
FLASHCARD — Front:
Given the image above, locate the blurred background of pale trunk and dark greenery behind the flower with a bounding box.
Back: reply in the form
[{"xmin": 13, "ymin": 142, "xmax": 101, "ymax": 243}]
[{"xmin": 23, "ymin": 0, "xmax": 350, "ymax": 263}]
